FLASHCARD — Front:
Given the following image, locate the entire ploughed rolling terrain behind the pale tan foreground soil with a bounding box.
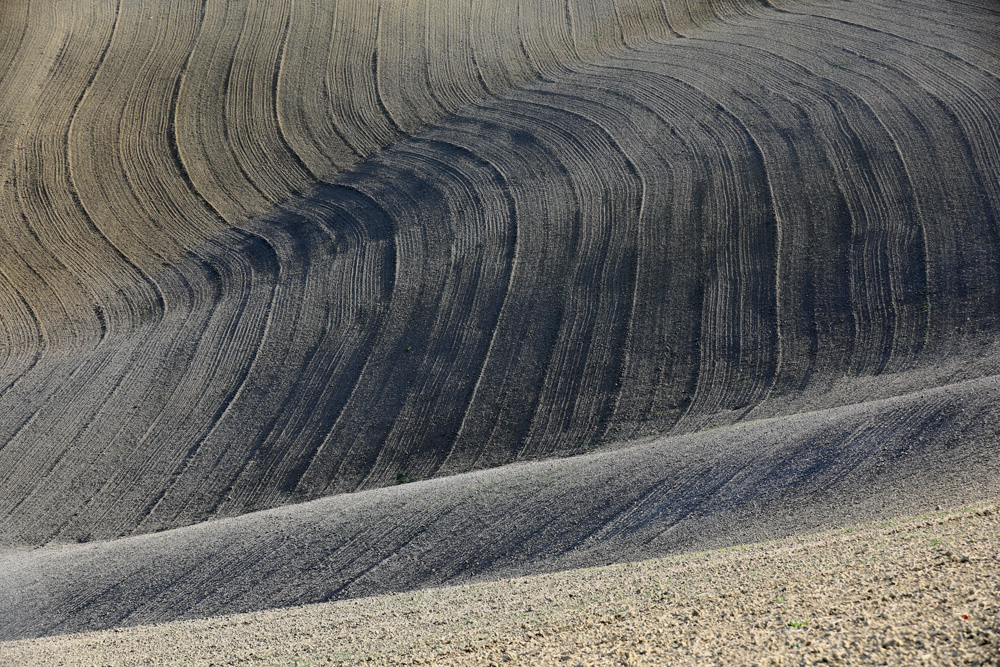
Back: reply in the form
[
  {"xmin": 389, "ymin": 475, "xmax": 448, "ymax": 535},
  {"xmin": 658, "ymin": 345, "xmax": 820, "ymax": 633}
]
[{"xmin": 0, "ymin": 0, "xmax": 1000, "ymax": 637}]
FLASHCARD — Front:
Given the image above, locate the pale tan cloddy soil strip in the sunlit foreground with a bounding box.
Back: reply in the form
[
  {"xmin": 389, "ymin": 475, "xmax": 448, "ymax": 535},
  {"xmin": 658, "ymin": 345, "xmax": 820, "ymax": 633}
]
[{"xmin": 0, "ymin": 500, "xmax": 1000, "ymax": 666}]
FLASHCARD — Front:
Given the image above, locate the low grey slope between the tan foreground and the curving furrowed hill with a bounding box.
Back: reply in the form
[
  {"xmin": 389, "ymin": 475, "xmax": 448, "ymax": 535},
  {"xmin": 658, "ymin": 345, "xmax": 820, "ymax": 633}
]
[{"xmin": 0, "ymin": 376, "xmax": 1000, "ymax": 639}]
